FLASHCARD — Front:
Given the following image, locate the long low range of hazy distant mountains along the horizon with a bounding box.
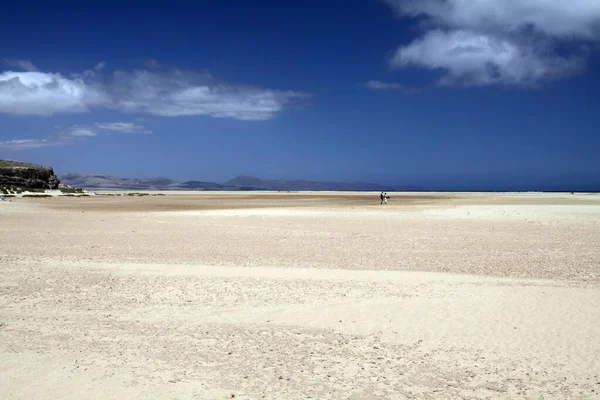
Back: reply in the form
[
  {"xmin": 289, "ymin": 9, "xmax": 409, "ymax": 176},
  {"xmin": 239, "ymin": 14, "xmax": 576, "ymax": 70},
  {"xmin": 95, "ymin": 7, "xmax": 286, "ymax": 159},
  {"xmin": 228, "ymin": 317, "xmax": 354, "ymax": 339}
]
[{"xmin": 60, "ymin": 174, "xmax": 408, "ymax": 191}]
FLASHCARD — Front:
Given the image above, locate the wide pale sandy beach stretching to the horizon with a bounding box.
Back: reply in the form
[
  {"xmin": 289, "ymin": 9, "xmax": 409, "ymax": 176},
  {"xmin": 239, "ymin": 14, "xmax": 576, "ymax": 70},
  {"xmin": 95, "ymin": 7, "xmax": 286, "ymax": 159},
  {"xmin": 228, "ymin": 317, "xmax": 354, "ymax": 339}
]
[{"xmin": 0, "ymin": 192, "xmax": 600, "ymax": 399}]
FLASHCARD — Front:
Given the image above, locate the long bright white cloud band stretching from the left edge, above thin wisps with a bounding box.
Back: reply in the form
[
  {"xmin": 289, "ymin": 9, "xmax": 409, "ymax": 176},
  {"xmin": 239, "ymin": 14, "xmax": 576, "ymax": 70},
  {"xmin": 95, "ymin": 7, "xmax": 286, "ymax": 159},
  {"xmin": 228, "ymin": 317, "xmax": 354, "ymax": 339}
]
[{"xmin": 0, "ymin": 68, "xmax": 308, "ymax": 120}]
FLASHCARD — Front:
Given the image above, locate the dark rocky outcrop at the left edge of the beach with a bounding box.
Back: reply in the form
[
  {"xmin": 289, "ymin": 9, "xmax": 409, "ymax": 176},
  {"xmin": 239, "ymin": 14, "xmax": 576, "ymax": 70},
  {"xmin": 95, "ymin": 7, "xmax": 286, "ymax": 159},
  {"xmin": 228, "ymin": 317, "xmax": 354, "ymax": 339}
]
[{"xmin": 0, "ymin": 160, "xmax": 60, "ymax": 189}]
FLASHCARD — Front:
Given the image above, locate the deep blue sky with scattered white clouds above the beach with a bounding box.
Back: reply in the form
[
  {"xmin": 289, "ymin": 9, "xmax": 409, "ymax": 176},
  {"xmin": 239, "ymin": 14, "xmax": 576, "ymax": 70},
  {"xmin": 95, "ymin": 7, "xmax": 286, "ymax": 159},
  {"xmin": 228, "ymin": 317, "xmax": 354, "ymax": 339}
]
[{"xmin": 0, "ymin": 0, "xmax": 600, "ymax": 190}]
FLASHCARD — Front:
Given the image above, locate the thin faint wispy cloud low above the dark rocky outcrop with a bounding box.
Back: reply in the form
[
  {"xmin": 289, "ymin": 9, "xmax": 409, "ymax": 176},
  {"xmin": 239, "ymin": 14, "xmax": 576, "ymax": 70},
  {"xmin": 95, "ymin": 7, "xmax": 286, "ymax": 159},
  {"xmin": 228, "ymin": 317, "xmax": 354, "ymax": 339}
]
[{"xmin": 0, "ymin": 122, "xmax": 152, "ymax": 151}]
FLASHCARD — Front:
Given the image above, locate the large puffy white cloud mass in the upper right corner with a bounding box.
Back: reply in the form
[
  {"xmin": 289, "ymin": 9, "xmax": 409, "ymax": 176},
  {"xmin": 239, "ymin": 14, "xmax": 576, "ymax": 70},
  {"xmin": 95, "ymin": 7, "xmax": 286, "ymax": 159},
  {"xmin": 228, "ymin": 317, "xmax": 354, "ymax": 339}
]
[{"xmin": 386, "ymin": 0, "xmax": 600, "ymax": 85}]
